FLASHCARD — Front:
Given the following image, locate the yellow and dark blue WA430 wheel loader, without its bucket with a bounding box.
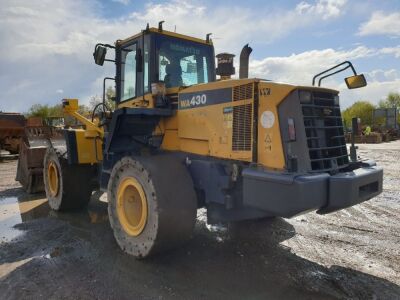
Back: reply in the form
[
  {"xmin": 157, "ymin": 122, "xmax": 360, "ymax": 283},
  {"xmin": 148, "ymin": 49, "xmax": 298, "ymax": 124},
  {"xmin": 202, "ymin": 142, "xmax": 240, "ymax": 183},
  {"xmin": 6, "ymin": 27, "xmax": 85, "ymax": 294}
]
[{"xmin": 44, "ymin": 22, "xmax": 383, "ymax": 258}]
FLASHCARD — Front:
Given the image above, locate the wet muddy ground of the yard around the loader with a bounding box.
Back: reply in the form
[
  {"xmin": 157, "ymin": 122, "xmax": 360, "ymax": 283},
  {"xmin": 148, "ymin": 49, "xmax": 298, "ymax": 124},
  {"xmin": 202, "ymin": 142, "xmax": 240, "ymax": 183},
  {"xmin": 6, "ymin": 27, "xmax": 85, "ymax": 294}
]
[{"xmin": 0, "ymin": 141, "xmax": 400, "ymax": 299}]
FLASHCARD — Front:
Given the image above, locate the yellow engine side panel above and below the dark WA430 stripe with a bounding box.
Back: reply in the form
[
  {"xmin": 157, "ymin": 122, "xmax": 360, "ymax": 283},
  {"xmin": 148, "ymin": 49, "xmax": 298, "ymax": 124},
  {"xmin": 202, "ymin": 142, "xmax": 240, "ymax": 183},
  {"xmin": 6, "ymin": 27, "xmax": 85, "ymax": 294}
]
[{"xmin": 159, "ymin": 79, "xmax": 254, "ymax": 162}]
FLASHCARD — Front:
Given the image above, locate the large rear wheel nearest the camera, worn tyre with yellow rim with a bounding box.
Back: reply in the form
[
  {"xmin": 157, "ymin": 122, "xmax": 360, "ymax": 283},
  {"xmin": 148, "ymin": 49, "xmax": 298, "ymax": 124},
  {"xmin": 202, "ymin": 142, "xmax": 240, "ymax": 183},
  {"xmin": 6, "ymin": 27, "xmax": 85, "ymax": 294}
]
[{"xmin": 107, "ymin": 154, "xmax": 197, "ymax": 258}]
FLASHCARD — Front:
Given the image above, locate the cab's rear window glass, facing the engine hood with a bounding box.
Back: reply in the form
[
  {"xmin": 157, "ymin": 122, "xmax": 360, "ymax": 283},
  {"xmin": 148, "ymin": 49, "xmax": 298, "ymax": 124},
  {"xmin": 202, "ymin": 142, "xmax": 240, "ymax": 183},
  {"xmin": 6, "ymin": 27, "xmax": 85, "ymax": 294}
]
[{"xmin": 156, "ymin": 35, "xmax": 215, "ymax": 88}]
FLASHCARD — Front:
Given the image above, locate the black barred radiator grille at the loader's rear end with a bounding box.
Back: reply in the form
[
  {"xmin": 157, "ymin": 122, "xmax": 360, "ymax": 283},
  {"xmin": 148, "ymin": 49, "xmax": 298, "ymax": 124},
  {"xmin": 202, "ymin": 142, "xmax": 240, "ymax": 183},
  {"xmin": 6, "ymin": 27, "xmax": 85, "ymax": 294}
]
[{"xmin": 302, "ymin": 92, "xmax": 349, "ymax": 171}]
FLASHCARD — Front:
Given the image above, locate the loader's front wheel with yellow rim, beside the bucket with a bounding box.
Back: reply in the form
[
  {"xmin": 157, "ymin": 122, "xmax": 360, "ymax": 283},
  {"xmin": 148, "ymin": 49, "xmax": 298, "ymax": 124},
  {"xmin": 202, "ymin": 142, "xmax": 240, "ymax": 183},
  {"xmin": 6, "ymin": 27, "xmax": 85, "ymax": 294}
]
[{"xmin": 43, "ymin": 147, "xmax": 93, "ymax": 211}]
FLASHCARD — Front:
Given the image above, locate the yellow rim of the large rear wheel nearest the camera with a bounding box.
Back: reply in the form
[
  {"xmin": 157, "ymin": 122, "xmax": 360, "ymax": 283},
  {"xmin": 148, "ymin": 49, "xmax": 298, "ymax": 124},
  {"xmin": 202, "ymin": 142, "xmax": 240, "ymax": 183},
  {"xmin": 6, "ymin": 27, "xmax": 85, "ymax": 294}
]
[{"xmin": 117, "ymin": 177, "xmax": 147, "ymax": 236}]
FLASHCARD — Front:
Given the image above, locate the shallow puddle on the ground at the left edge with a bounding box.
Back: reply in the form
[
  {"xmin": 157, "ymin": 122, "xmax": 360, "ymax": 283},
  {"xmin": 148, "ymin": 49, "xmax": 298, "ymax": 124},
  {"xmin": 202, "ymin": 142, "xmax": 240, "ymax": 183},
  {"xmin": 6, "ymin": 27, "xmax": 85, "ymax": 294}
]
[{"xmin": 0, "ymin": 197, "xmax": 49, "ymax": 243}]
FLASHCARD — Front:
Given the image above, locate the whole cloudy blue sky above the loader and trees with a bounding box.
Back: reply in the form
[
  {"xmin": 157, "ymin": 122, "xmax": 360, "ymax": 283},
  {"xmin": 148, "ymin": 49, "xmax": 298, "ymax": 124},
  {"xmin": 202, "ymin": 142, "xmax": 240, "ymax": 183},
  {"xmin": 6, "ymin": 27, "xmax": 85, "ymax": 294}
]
[{"xmin": 0, "ymin": 0, "xmax": 400, "ymax": 112}]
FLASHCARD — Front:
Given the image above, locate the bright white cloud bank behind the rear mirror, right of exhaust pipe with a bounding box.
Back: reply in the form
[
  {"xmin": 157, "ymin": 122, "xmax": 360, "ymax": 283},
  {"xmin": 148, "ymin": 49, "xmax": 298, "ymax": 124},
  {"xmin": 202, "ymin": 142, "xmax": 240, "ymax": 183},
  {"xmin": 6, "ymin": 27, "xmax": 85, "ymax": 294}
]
[{"xmin": 250, "ymin": 46, "xmax": 400, "ymax": 107}]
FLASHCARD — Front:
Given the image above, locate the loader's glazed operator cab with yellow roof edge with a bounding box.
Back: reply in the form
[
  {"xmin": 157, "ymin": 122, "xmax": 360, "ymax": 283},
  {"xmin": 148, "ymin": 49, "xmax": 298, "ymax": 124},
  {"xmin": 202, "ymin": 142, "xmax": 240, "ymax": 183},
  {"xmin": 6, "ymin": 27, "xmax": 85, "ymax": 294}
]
[{"xmin": 111, "ymin": 28, "xmax": 216, "ymax": 104}]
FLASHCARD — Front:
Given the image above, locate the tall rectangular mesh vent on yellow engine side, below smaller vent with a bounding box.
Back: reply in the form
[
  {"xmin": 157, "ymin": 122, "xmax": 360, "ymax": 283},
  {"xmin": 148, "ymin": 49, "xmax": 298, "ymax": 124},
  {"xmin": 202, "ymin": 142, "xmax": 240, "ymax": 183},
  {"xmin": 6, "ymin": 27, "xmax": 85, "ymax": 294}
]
[{"xmin": 232, "ymin": 104, "xmax": 252, "ymax": 151}]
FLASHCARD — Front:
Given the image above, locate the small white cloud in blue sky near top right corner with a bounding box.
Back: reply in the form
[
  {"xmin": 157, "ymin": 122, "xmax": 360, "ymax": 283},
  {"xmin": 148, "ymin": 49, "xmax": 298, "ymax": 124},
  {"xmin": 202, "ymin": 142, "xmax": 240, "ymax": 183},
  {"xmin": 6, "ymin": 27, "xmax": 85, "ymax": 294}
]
[{"xmin": 358, "ymin": 11, "xmax": 400, "ymax": 37}]
